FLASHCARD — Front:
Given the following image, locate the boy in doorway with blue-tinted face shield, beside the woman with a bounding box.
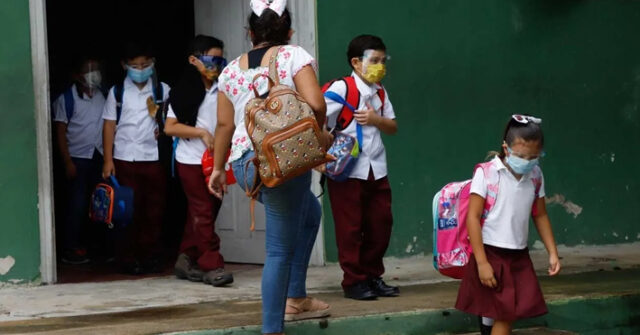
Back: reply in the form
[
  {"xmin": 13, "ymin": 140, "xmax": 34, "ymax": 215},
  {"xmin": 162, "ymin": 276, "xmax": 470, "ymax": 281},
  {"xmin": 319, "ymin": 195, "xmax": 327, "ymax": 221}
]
[{"xmin": 164, "ymin": 35, "xmax": 233, "ymax": 286}]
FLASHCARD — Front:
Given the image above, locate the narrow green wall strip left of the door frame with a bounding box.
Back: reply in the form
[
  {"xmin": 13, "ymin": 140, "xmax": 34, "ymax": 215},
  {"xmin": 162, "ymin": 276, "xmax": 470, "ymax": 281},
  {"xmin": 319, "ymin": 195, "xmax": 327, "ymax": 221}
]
[{"xmin": 0, "ymin": 0, "xmax": 40, "ymax": 281}]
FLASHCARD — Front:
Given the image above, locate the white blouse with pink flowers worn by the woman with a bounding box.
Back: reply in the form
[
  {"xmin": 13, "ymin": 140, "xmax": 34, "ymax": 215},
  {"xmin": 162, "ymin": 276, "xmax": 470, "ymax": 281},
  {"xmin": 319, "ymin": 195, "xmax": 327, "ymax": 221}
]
[{"xmin": 218, "ymin": 45, "xmax": 317, "ymax": 163}]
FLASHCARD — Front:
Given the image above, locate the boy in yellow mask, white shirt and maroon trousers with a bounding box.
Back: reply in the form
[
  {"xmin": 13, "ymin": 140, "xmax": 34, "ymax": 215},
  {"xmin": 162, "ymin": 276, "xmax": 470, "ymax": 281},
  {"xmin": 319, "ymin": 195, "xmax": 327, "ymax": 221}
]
[{"xmin": 325, "ymin": 35, "xmax": 400, "ymax": 300}]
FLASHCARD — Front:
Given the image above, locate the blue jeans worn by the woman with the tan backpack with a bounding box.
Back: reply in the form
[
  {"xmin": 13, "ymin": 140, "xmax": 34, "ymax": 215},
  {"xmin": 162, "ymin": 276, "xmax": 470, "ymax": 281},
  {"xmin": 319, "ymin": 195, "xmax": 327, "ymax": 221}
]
[{"xmin": 231, "ymin": 151, "xmax": 322, "ymax": 334}]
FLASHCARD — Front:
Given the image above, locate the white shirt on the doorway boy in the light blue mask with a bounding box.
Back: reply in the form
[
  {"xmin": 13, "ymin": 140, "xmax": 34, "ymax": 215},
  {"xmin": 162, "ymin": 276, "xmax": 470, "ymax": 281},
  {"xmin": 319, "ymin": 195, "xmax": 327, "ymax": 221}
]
[{"xmin": 102, "ymin": 77, "xmax": 170, "ymax": 162}]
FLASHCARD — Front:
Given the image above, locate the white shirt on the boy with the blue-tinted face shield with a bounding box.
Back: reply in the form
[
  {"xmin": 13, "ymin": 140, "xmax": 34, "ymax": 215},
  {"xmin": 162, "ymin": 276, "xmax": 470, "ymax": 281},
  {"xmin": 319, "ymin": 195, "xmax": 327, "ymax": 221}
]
[{"xmin": 167, "ymin": 83, "xmax": 218, "ymax": 165}]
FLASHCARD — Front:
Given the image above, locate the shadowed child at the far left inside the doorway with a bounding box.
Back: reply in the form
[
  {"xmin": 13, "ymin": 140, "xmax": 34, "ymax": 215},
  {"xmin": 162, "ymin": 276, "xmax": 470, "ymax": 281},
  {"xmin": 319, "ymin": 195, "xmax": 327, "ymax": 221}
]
[{"xmin": 53, "ymin": 57, "xmax": 105, "ymax": 264}]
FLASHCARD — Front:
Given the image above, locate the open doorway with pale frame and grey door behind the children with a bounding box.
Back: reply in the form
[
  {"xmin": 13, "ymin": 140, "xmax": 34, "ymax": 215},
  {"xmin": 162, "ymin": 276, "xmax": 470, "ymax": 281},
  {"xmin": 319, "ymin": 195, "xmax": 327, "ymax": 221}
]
[{"xmin": 31, "ymin": 0, "xmax": 324, "ymax": 283}]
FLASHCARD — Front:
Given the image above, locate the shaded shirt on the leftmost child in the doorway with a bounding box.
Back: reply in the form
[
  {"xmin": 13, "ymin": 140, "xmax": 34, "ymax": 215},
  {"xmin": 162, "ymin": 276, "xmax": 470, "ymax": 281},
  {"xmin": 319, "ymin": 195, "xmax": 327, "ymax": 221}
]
[{"xmin": 53, "ymin": 84, "xmax": 105, "ymax": 159}]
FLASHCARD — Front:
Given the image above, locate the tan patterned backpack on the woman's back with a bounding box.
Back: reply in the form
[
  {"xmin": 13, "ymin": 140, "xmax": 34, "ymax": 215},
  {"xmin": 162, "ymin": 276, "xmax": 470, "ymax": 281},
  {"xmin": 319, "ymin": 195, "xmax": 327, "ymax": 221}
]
[{"xmin": 245, "ymin": 47, "xmax": 331, "ymax": 197}]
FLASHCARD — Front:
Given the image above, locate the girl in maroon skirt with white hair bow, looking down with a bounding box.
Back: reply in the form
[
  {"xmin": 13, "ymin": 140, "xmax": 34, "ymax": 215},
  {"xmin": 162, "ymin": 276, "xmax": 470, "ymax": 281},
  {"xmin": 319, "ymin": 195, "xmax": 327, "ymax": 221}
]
[{"xmin": 456, "ymin": 115, "xmax": 560, "ymax": 335}]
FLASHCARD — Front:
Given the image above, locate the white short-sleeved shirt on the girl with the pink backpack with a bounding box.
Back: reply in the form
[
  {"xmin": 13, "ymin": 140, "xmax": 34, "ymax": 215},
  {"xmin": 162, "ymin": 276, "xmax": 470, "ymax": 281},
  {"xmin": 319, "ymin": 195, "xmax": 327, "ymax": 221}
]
[{"xmin": 470, "ymin": 157, "xmax": 545, "ymax": 250}]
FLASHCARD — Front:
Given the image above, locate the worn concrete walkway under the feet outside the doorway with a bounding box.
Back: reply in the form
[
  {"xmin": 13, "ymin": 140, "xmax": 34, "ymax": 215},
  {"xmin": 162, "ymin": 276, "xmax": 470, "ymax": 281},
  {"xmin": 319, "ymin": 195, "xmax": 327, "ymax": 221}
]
[{"xmin": 0, "ymin": 243, "xmax": 640, "ymax": 335}]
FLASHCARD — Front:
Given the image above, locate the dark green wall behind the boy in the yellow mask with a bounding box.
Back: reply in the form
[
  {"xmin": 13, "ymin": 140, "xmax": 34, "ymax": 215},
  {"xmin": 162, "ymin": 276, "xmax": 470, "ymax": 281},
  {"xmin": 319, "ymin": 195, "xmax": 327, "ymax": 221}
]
[{"xmin": 317, "ymin": 0, "xmax": 640, "ymax": 261}]
